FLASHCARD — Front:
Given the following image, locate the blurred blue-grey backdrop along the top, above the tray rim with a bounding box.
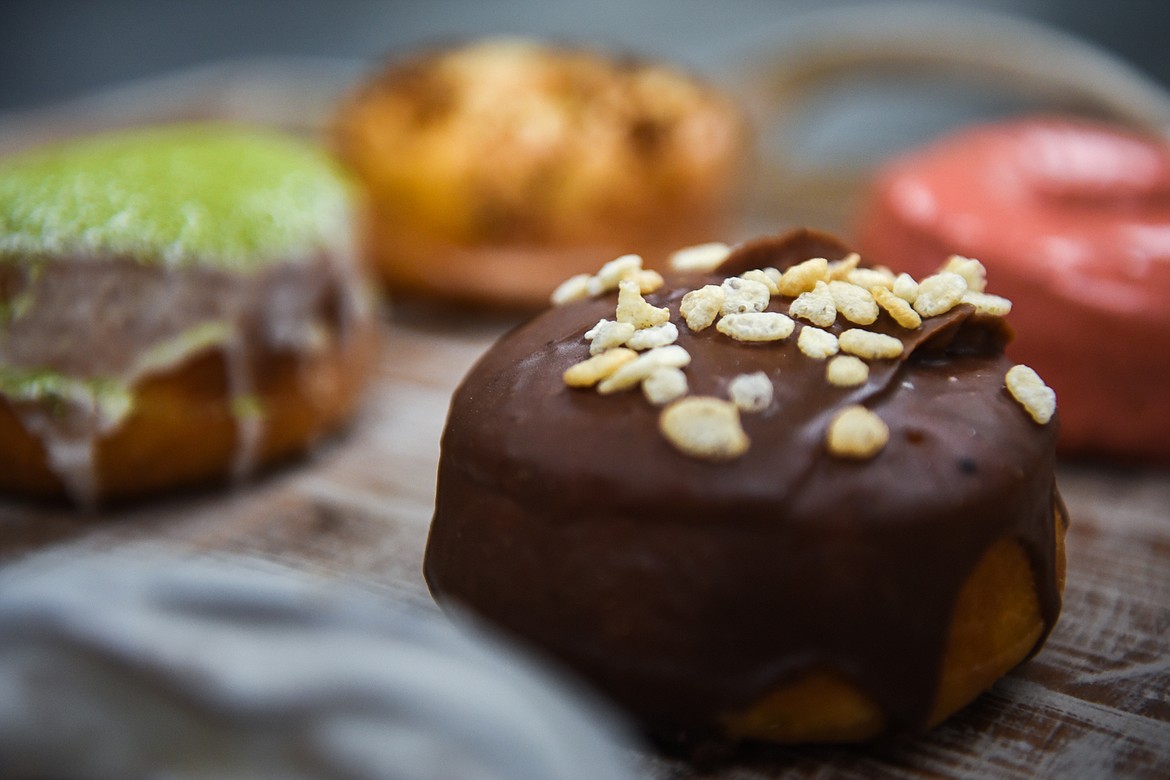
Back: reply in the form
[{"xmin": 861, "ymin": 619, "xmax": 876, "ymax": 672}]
[{"xmin": 0, "ymin": 0, "xmax": 1170, "ymax": 112}]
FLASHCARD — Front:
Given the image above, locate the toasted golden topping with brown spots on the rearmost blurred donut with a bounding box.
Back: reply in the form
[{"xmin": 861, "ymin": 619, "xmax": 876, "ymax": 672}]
[{"xmin": 335, "ymin": 39, "xmax": 744, "ymax": 244}]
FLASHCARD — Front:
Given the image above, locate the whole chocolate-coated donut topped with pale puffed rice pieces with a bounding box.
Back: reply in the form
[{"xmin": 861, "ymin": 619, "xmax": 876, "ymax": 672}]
[{"xmin": 424, "ymin": 232, "xmax": 1067, "ymax": 743}]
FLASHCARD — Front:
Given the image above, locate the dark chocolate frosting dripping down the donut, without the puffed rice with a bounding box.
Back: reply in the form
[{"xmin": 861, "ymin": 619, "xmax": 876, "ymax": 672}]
[{"xmin": 425, "ymin": 232, "xmax": 1061, "ymax": 731}]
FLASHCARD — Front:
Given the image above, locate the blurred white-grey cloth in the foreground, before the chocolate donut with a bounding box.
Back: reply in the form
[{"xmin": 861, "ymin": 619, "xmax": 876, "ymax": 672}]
[{"xmin": 0, "ymin": 553, "xmax": 632, "ymax": 780}]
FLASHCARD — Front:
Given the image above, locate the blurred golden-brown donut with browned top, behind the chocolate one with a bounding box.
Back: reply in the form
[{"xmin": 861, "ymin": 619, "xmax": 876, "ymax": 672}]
[{"xmin": 333, "ymin": 39, "xmax": 745, "ymax": 308}]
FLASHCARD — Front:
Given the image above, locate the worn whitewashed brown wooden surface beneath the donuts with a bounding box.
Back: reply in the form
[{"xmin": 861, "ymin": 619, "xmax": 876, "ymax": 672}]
[{"xmin": 0, "ymin": 306, "xmax": 1170, "ymax": 780}]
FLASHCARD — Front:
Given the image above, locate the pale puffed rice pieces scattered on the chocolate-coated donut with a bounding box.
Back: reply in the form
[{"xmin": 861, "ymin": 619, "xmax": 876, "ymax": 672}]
[{"xmin": 553, "ymin": 244, "xmax": 1055, "ymax": 462}]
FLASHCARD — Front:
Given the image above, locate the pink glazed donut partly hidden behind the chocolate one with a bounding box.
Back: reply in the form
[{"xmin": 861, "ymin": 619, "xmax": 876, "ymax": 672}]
[{"xmin": 856, "ymin": 118, "xmax": 1170, "ymax": 461}]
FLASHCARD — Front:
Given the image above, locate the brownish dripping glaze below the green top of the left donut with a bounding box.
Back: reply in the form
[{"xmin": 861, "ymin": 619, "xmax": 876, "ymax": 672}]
[{"xmin": 0, "ymin": 250, "xmax": 367, "ymax": 505}]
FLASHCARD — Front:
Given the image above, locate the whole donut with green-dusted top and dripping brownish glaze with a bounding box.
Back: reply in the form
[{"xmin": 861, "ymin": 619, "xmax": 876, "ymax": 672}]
[{"xmin": 0, "ymin": 125, "xmax": 376, "ymax": 505}]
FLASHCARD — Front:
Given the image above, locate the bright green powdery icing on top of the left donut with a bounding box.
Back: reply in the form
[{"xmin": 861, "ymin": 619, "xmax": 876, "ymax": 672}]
[{"xmin": 0, "ymin": 124, "xmax": 352, "ymax": 271}]
